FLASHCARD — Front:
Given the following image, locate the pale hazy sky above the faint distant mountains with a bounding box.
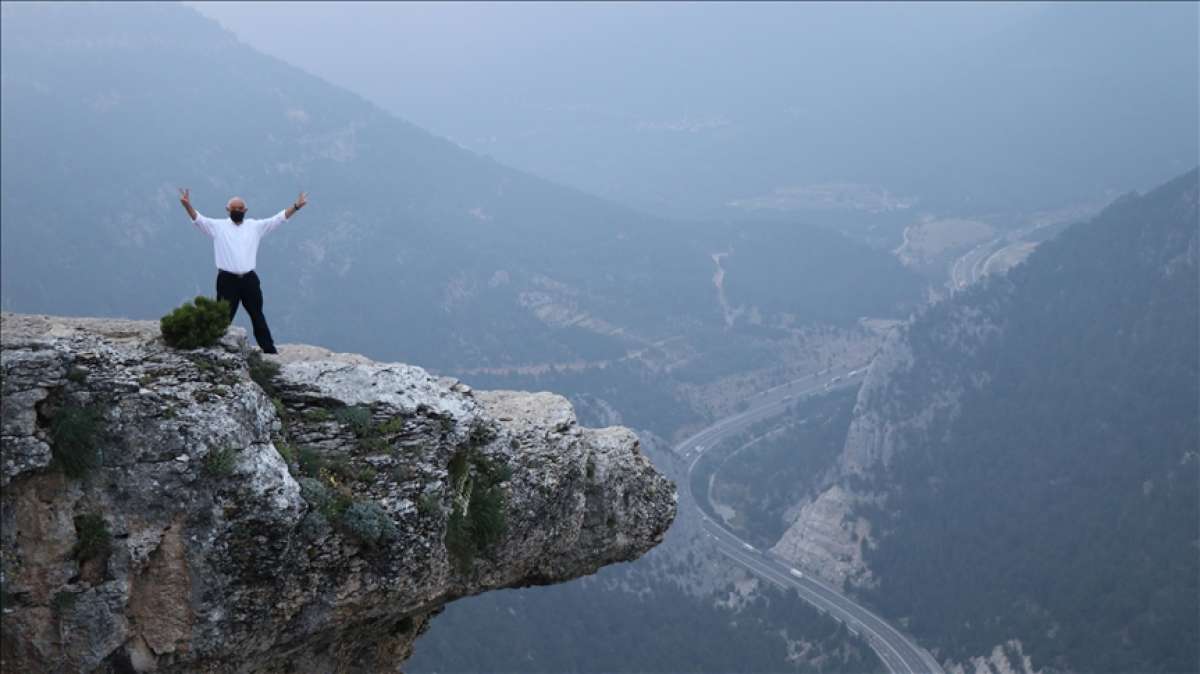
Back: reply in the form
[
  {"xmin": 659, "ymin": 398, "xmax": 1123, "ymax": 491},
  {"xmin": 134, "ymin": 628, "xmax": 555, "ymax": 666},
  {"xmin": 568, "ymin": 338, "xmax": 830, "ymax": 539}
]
[{"xmin": 191, "ymin": 2, "xmax": 1043, "ymax": 125}]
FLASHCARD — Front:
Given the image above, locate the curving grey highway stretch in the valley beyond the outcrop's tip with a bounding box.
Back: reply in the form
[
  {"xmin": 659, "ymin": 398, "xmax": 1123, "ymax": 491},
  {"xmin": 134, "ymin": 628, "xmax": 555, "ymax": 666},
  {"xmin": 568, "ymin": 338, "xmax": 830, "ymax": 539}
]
[{"xmin": 674, "ymin": 365, "xmax": 943, "ymax": 674}]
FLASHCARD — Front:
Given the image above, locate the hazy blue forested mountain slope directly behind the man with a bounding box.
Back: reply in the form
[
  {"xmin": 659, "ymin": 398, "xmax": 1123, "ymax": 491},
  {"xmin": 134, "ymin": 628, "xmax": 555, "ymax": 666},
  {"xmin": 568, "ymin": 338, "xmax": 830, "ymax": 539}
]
[{"xmin": 0, "ymin": 4, "xmax": 919, "ymax": 383}]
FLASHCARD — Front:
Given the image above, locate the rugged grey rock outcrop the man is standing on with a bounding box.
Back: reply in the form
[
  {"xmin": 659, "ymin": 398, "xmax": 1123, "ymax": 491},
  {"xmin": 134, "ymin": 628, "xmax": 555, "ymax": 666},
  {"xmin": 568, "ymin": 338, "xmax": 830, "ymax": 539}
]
[{"xmin": 0, "ymin": 313, "xmax": 676, "ymax": 672}]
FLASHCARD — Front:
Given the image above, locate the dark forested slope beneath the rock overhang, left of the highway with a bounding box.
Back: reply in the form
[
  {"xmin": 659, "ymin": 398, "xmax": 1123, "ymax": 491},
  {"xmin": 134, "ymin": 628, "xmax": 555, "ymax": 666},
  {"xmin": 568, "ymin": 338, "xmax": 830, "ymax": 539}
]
[{"xmin": 404, "ymin": 568, "xmax": 884, "ymax": 674}]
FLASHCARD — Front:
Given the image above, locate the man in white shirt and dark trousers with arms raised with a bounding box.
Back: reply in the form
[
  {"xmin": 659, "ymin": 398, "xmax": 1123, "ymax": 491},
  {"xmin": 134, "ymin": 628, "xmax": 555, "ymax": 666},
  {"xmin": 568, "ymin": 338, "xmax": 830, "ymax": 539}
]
[{"xmin": 179, "ymin": 189, "xmax": 308, "ymax": 354}]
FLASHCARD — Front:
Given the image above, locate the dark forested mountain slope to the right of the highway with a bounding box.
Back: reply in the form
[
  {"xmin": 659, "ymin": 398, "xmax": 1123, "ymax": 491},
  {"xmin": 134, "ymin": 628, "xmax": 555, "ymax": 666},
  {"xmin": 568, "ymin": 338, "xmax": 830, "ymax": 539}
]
[{"xmin": 776, "ymin": 170, "xmax": 1200, "ymax": 672}]
